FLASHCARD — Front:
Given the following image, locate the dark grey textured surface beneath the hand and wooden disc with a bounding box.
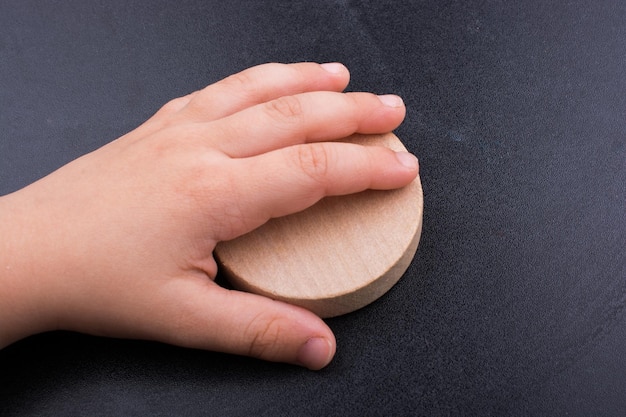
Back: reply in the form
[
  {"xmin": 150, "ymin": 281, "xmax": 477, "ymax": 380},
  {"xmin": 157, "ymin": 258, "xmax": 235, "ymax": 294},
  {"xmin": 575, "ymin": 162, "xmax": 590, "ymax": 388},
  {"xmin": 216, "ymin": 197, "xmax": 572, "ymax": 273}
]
[{"xmin": 0, "ymin": 0, "xmax": 626, "ymax": 416}]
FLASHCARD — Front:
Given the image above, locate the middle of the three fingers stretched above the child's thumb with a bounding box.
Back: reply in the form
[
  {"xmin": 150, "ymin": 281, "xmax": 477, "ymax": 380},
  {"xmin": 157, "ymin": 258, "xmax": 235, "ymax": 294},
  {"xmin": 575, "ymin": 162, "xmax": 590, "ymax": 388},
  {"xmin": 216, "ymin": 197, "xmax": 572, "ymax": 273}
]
[{"xmin": 199, "ymin": 91, "xmax": 406, "ymax": 158}]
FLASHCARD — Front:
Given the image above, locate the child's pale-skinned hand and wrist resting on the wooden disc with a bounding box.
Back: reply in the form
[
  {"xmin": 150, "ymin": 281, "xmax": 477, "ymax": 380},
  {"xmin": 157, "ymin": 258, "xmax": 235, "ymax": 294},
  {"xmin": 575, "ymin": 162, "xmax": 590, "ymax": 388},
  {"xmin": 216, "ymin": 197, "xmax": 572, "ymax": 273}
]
[{"xmin": 0, "ymin": 63, "xmax": 418, "ymax": 369}]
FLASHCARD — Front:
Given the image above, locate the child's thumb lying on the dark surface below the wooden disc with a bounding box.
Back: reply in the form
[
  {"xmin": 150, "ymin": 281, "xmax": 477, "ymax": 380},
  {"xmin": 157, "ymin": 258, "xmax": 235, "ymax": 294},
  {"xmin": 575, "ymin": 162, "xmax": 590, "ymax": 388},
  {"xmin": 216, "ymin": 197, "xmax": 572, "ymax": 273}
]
[{"xmin": 149, "ymin": 279, "xmax": 336, "ymax": 370}]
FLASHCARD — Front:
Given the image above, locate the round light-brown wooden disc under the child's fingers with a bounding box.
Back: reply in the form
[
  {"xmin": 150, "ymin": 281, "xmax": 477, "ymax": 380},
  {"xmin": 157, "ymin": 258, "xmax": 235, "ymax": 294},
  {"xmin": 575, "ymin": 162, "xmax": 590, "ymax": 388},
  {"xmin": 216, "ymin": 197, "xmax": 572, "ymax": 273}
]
[{"xmin": 215, "ymin": 133, "xmax": 423, "ymax": 317}]
